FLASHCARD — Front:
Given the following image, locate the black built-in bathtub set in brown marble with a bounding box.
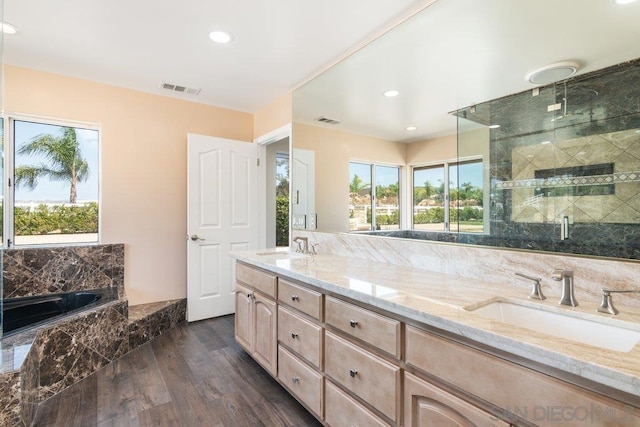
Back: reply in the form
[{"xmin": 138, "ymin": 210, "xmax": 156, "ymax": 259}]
[{"xmin": 2, "ymin": 288, "xmax": 118, "ymax": 337}]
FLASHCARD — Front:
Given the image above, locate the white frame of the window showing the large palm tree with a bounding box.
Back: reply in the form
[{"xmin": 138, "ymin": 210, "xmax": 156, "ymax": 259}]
[{"xmin": 0, "ymin": 112, "xmax": 102, "ymax": 249}]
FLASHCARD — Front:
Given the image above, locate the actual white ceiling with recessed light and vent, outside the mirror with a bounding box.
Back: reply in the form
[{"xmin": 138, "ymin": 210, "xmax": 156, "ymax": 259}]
[{"xmin": 4, "ymin": 0, "xmax": 427, "ymax": 112}]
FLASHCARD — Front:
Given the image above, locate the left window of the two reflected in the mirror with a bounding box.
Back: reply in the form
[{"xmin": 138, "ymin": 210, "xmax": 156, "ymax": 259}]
[{"xmin": 349, "ymin": 162, "xmax": 400, "ymax": 231}]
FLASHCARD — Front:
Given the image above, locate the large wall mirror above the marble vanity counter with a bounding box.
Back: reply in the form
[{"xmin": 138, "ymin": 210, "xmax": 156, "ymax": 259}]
[{"xmin": 291, "ymin": 0, "xmax": 640, "ymax": 259}]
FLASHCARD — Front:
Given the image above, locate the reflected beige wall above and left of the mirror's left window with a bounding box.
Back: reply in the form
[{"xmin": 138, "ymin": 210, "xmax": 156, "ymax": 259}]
[{"xmin": 293, "ymin": 123, "xmax": 406, "ymax": 232}]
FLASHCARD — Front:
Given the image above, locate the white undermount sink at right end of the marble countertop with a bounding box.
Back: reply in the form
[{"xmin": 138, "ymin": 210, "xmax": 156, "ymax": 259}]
[{"xmin": 467, "ymin": 301, "xmax": 640, "ymax": 353}]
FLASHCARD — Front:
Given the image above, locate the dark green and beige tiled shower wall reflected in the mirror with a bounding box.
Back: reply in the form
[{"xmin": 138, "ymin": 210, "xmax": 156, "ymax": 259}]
[{"xmin": 454, "ymin": 56, "xmax": 640, "ymax": 259}]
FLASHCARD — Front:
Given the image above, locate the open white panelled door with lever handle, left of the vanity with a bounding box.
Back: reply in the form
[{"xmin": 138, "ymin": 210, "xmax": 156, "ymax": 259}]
[{"xmin": 187, "ymin": 134, "xmax": 258, "ymax": 322}]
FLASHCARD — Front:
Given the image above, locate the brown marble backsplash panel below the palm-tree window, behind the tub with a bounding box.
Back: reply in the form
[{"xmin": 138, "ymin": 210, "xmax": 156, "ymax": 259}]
[{"xmin": 2, "ymin": 244, "xmax": 124, "ymax": 298}]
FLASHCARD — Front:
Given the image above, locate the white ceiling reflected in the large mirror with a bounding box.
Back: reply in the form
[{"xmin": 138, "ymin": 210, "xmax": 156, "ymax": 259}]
[{"xmin": 294, "ymin": 0, "xmax": 640, "ymax": 142}]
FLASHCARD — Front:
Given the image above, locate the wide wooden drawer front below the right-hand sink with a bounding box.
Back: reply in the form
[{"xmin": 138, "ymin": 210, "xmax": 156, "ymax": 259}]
[{"xmin": 406, "ymin": 326, "xmax": 640, "ymax": 426}]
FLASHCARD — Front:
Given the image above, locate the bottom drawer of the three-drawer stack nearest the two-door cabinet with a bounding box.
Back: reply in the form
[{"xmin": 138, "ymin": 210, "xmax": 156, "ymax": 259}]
[{"xmin": 278, "ymin": 346, "xmax": 322, "ymax": 417}]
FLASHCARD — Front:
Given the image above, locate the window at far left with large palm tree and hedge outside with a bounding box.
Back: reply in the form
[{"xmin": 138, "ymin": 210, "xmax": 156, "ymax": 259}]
[{"xmin": 2, "ymin": 117, "xmax": 100, "ymax": 247}]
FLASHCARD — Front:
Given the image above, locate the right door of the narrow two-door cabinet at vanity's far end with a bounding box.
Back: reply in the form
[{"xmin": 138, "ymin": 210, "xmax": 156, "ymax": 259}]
[{"xmin": 253, "ymin": 292, "xmax": 278, "ymax": 377}]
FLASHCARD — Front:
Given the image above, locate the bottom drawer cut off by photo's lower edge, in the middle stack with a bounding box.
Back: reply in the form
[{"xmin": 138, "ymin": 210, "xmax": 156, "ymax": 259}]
[{"xmin": 324, "ymin": 381, "xmax": 389, "ymax": 427}]
